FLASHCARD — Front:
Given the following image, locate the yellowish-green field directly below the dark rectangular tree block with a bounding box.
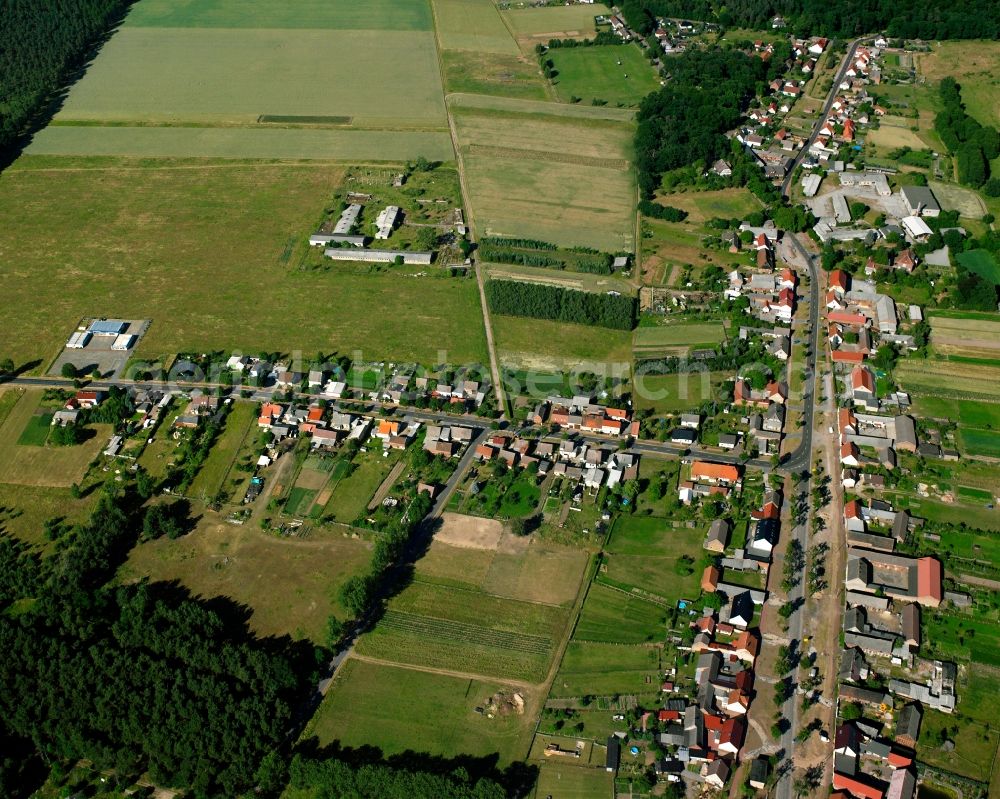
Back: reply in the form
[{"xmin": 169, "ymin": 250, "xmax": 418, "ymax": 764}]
[{"xmin": 490, "ymin": 315, "xmax": 632, "ymax": 374}]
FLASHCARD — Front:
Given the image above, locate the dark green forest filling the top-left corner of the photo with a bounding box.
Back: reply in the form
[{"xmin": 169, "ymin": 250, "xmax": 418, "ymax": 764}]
[{"xmin": 0, "ymin": 0, "xmax": 133, "ymax": 152}]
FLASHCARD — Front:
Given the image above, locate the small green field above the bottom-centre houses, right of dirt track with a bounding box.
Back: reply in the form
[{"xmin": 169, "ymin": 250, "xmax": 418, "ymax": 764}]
[{"xmin": 550, "ymin": 640, "xmax": 660, "ymax": 697}]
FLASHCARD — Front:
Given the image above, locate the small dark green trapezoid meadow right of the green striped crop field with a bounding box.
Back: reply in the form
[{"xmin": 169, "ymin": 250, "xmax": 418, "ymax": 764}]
[{"xmin": 573, "ymin": 583, "xmax": 666, "ymax": 644}]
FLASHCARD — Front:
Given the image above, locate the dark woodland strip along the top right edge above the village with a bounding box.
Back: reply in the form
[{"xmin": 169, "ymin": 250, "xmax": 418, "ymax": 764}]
[{"xmin": 618, "ymin": 0, "xmax": 1000, "ymax": 39}]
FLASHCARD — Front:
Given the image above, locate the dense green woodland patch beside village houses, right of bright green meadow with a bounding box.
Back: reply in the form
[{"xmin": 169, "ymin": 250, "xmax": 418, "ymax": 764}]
[{"xmin": 635, "ymin": 48, "xmax": 768, "ymax": 199}]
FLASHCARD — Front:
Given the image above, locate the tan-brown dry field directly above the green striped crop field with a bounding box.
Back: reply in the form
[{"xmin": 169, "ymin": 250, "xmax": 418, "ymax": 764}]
[{"xmin": 416, "ymin": 533, "xmax": 588, "ymax": 607}]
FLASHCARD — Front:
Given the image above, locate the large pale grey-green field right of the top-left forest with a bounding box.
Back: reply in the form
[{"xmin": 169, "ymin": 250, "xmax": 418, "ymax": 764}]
[{"xmin": 56, "ymin": 27, "xmax": 445, "ymax": 128}]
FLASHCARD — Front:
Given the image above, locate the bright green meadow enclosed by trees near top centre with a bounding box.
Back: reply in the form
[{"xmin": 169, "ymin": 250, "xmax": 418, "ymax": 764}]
[{"xmin": 548, "ymin": 44, "xmax": 660, "ymax": 106}]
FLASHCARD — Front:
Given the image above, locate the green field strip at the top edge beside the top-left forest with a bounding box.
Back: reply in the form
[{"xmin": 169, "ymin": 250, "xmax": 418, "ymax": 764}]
[{"xmin": 125, "ymin": 0, "xmax": 432, "ymax": 31}]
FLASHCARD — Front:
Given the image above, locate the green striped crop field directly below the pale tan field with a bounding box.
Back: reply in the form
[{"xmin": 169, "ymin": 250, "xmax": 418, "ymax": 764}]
[{"xmin": 357, "ymin": 582, "xmax": 568, "ymax": 683}]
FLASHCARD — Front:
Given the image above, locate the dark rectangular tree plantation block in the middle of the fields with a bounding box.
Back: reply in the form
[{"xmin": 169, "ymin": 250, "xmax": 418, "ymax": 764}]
[{"xmin": 486, "ymin": 280, "xmax": 637, "ymax": 330}]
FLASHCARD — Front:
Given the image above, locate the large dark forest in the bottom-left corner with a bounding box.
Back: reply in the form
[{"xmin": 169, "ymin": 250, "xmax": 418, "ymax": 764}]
[{"xmin": 0, "ymin": 482, "xmax": 325, "ymax": 796}]
